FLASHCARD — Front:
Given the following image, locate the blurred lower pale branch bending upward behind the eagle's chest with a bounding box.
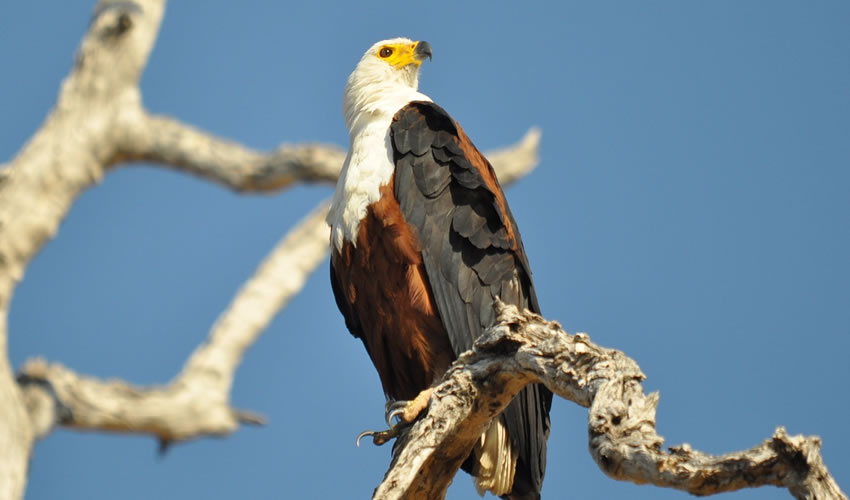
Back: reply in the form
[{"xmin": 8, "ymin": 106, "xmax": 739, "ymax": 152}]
[{"xmin": 18, "ymin": 203, "xmax": 328, "ymax": 443}]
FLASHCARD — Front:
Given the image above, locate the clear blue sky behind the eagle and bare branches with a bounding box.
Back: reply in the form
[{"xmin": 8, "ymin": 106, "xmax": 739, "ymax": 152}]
[{"xmin": 0, "ymin": 0, "xmax": 850, "ymax": 500}]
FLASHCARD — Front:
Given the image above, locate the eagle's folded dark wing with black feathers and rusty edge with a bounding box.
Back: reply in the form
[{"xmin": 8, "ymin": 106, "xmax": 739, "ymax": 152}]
[{"xmin": 390, "ymin": 102, "xmax": 552, "ymax": 496}]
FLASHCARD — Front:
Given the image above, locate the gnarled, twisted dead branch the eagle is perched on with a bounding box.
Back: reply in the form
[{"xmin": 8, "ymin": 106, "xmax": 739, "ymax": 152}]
[{"xmin": 374, "ymin": 306, "xmax": 847, "ymax": 500}]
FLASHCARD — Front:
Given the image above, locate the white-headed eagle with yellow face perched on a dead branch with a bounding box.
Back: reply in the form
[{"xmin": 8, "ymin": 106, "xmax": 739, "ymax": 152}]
[{"xmin": 327, "ymin": 38, "xmax": 552, "ymax": 500}]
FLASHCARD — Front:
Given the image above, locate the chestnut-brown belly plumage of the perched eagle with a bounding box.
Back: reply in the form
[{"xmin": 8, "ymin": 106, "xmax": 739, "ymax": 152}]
[{"xmin": 331, "ymin": 182, "xmax": 454, "ymax": 400}]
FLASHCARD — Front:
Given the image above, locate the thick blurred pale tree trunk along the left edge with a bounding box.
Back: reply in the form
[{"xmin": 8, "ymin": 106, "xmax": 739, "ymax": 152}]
[{"xmin": 0, "ymin": 0, "xmax": 164, "ymax": 499}]
